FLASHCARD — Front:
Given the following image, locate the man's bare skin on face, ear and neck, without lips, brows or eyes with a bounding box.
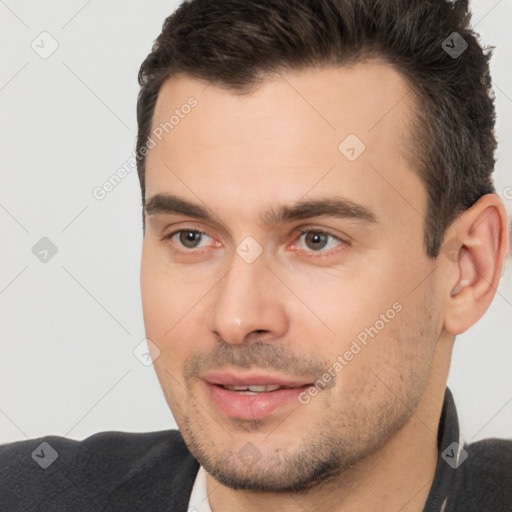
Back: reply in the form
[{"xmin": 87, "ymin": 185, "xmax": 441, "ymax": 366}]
[{"xmin": 141, "ymin": 61, "xmax": 508, "ymax": 512}]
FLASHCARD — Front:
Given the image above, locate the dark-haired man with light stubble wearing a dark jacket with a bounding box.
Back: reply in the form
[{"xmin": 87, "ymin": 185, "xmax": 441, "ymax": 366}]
[{"xmin": 0, "ymin": 0, "xmax": 512, "ymax": 512}]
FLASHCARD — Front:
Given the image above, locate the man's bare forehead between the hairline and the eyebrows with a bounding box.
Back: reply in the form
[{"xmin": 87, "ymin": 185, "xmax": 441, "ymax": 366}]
[{"xmin": 146, "ymin": 62, "xmax": 425, "ymax": 228}]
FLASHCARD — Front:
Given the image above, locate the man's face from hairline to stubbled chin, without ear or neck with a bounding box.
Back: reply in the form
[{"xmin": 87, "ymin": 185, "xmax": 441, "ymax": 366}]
[{"xmin": 141, "ymin": 62, "xmax": 442, "ymax": 492}]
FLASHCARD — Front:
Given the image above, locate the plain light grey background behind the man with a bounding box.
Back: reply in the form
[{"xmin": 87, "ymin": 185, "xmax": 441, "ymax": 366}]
[{"xmin": 0, "ymin": 0, "xmax": 512, "ymax": 442}]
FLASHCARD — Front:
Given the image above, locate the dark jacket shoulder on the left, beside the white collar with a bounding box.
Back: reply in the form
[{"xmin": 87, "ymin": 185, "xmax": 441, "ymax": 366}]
[{"xmin": 0, "ymin": 430, "xmax": 199, "ymax": 512}]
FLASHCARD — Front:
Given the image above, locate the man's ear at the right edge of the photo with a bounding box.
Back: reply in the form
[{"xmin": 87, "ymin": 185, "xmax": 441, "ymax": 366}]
[{"xmin": 440, "ymin": 194, "xmax": 510, "ymax": 335}]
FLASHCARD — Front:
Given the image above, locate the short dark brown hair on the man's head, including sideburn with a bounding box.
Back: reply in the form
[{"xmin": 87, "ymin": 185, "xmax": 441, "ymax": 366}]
[{"xmin": 137, "ymin": 0, "xmax": 496, "ymax": 258}]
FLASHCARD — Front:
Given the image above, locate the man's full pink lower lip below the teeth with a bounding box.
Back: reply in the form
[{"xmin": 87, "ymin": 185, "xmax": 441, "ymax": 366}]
[{"xmin": 202, "ymin": 381, "xmax": 312, "ymax": 420}]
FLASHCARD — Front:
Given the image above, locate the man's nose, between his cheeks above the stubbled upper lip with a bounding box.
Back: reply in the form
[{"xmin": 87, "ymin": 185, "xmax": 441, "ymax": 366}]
[{"xmin": 209, "ymin": 248, "xmax": 289, "ymax": 344}]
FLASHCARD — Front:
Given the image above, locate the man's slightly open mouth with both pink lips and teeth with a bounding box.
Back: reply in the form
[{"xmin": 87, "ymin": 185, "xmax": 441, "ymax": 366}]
[{"xmin": 201, "ymin": 372, "xmax": 313, "ymax": 421}]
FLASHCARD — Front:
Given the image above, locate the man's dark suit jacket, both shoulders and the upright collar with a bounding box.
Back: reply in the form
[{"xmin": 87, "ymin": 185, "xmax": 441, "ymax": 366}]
[{"xmin": 0, "ymin": 389, "xmax": 512, "ymax": 512}]
